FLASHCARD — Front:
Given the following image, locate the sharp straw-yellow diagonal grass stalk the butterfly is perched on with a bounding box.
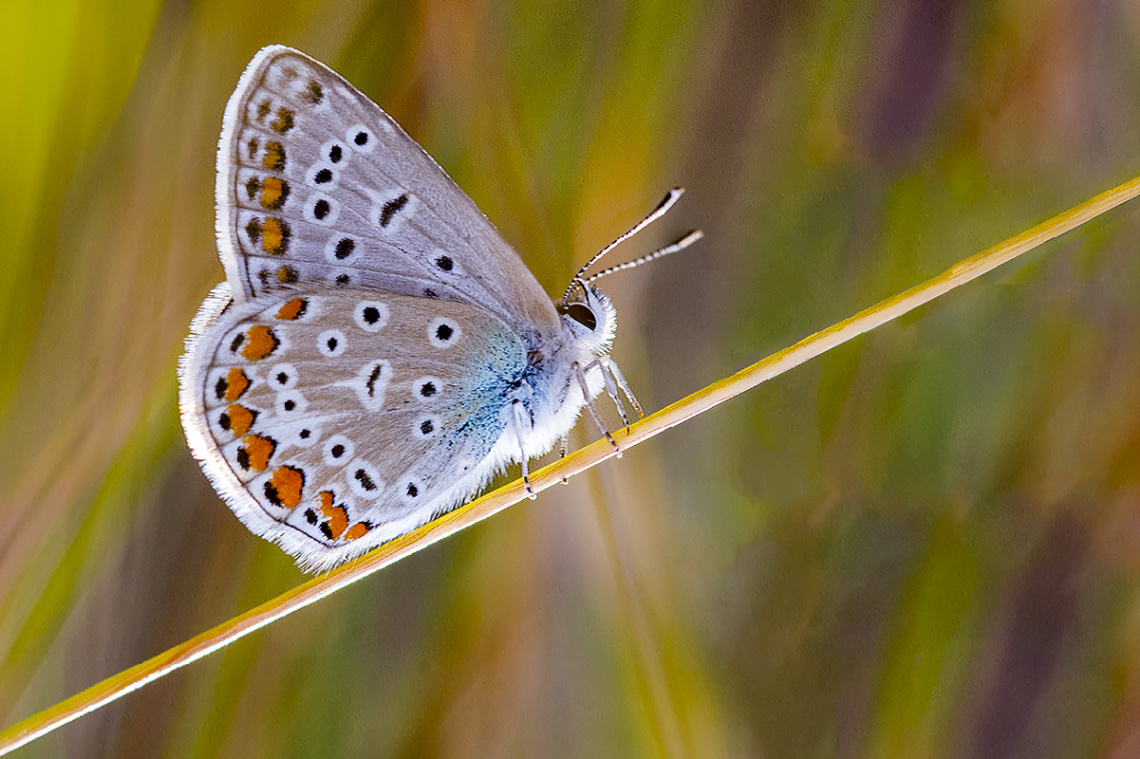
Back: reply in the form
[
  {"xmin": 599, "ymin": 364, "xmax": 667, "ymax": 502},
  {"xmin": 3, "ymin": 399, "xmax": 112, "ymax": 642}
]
[{"xmin": 0, "ymin": 177, "xmax": 1140, "ymax": 756}]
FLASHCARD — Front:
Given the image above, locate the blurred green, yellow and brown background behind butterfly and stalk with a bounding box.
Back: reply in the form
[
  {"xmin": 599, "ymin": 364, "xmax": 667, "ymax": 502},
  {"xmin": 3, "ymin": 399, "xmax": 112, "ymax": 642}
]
[{"xmin": 0, "ymin": 0, "xmax": 1140, "ymax": 759}]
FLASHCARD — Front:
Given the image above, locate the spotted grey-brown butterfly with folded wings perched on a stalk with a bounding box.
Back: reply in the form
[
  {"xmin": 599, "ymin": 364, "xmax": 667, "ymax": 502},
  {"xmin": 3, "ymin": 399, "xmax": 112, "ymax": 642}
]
[{"xmin": 179, "ymin": 46, "xmax": 700, "ymax": 571}]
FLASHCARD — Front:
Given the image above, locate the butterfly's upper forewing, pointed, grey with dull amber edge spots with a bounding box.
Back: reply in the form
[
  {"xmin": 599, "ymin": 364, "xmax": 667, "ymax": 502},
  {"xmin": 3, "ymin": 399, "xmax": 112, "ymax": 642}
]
[{"xmin": 217, "ymin": 46, "xmax": 559, "ymax": 330}]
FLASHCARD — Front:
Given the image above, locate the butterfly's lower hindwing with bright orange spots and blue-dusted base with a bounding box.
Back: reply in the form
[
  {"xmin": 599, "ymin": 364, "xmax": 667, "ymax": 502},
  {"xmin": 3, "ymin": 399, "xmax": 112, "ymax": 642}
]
[{"xmin": 180, "ymin": 284, "xmax": 527, "ymax": 569}]
